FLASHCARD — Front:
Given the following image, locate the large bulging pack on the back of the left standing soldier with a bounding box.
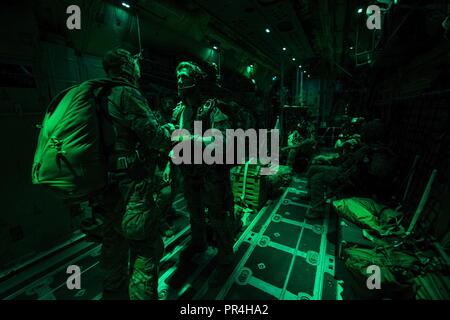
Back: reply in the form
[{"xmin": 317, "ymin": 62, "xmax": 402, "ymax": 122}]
[{"xmin": 32, "ymin": 78, "xmax": 134, "ymax": 200}]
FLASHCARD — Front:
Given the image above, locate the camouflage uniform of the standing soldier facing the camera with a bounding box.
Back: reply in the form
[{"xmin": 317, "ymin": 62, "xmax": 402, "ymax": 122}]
[{"xmin": 174, "ymin": 99, "xmax": 234, "ymax": 264}]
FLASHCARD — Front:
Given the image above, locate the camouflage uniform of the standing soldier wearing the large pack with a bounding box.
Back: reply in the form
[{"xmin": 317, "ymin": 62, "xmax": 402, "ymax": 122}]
[{"xmin": 98, "ymin": 78, "xmax": 170, "ymax": 300}]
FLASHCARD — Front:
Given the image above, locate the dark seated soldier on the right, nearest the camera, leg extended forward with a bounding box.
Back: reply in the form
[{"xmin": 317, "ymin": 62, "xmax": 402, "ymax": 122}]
[{"xmin": 307, "ymin": 120, "xmax": 395, "ymax": 218}]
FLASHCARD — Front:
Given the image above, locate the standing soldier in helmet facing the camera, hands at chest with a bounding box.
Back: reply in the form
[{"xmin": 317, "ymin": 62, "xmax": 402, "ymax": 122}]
[{"xmin": 169, "ymin": 62, "xmax": 234, "ymax": 274}]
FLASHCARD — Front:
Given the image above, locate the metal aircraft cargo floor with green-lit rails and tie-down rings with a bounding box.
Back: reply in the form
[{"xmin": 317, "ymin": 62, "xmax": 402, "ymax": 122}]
[{"xmin": 0, "ymin": 177, "xmax": 342, "ymax": 300}]
